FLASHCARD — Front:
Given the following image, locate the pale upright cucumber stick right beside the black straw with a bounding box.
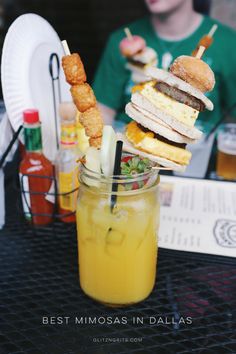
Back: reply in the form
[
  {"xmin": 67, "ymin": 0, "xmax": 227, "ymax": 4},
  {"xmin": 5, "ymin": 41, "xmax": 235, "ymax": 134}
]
[{"xmin": 101, "ymin": 125, "xmax": 117, "ymax": 177}]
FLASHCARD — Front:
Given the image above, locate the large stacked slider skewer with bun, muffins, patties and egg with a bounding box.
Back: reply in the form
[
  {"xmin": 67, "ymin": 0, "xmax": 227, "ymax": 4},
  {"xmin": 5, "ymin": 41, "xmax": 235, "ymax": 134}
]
[{"xmin": 124, "ymin": 51, "xmax": 215, "ymax": 171}]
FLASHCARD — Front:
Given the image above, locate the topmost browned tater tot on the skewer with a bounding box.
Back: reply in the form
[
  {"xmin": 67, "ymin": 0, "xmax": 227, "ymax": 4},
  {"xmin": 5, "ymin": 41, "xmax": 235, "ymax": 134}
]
[{"xmin": 62, "ymin": 53, "xmax": 86, "ymax": 85}]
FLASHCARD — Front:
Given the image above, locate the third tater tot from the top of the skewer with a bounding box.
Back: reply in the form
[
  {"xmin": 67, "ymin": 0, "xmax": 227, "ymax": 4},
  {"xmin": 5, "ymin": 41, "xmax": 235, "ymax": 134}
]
[{"xmin": 79, "ymin": 107, "xmax": 103, "ymax": 138}]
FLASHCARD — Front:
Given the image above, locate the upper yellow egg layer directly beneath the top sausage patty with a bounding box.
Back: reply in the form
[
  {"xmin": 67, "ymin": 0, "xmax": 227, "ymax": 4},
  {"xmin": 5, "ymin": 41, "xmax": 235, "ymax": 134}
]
[{"xmin": 140, "ymin": 85, "xmax": 199, "ymax": 127}]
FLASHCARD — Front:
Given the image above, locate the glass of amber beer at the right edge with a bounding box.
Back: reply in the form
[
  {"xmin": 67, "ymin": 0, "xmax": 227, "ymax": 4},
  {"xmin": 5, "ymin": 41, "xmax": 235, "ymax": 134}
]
[{"xmin": 216, "ymin": 124, "xmax": 236, "ymax": 180}]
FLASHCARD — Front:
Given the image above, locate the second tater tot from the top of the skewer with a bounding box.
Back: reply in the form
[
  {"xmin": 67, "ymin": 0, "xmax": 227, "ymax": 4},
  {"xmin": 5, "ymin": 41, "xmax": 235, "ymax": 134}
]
[{"xmin": 70, "ymin": 83, "xmax": 96, "ymax": 112}]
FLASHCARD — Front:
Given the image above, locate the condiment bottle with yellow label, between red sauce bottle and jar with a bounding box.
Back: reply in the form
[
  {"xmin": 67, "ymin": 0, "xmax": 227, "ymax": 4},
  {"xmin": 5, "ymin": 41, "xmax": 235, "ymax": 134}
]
[{"xmin": 56, "ymin": 102, "xmax": 79, "ymax": 222}]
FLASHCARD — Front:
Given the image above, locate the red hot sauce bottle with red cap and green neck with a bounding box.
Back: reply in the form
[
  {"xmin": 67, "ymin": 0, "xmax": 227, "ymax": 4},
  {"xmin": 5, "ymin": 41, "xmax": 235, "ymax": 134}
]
[{"xmin": 19, "ymin": 109, "xmax": 54, "ymax": 225}]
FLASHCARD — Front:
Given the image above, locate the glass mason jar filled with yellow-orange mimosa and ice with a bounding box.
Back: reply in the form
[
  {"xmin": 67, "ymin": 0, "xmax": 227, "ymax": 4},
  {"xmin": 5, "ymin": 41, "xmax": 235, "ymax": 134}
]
[{"xmin": 77, "ymin": 159, "xmax": 159, "ymax": 306}]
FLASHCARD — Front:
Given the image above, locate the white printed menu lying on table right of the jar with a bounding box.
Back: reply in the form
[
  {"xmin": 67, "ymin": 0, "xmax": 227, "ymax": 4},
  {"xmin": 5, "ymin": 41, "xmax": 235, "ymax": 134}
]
[{"xmin": 158, "ymin": 176, "xmax": 236, "ymax": 257}]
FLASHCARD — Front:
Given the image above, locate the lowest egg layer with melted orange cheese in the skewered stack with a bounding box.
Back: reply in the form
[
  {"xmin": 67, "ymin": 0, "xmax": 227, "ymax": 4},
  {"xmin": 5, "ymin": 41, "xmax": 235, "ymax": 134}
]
[{"xmin": 126, "ymin": 121, "xmax": 192, "ymax": 165}]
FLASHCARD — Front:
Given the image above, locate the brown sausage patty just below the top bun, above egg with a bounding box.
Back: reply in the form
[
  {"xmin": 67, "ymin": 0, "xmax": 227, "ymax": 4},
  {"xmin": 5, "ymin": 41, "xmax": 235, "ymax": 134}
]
[{"xmin": 154, "ymin": 82, "xmax": 205, "ymax": 112}]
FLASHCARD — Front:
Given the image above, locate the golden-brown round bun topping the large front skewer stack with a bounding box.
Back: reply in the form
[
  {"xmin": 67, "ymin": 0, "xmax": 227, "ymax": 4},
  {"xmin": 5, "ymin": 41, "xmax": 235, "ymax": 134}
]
[{"xmin": 170, "ymin": 55, "xmax": 215, "ymax": 92}]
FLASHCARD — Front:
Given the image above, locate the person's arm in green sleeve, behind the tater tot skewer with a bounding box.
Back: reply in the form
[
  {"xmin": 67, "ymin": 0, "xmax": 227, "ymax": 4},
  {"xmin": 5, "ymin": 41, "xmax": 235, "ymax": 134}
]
[{"xmin": 93, "ymin": 31, "xmax": 129, "ymax": 124}]
